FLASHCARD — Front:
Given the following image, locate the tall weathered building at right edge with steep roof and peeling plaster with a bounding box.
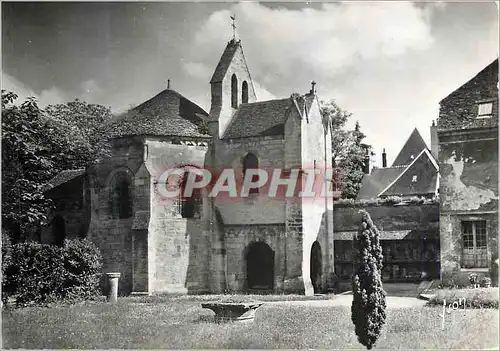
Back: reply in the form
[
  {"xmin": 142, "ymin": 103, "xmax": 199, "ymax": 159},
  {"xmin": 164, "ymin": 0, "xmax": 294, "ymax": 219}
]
[{"xmin": 438, "ymin": 61, "xmax": 498, "ymax": 284}]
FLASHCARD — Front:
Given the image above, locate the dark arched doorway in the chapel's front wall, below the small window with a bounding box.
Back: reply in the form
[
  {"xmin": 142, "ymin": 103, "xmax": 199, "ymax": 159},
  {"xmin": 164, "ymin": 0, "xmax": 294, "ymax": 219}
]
[{"xmin": 246, "ymin": 242, "xmax": 274, "ymax": 290}]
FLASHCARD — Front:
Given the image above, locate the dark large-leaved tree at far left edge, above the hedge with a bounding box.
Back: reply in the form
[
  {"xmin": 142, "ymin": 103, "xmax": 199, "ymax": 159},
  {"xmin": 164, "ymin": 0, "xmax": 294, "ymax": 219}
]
[{"xmin": 2, "ymin": 90, "xmax": 55, "ymax": 241}]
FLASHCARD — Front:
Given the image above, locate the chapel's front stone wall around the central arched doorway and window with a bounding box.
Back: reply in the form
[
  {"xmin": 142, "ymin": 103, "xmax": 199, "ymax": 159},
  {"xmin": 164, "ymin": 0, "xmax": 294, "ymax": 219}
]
[{"xmin": 210, "ymin": 136, "xmax": 286, "ymax": 292}]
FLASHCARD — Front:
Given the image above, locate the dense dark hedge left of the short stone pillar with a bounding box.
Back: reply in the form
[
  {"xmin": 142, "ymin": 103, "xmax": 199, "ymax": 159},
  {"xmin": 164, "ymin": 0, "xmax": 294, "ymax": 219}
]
[{"xmin": 2, "ymin": 238, "xmax": 102, "ymax": 306}]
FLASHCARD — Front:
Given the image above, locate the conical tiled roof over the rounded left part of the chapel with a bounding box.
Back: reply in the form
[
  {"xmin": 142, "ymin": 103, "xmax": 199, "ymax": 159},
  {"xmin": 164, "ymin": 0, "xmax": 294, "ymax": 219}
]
[{"xmin": 109, "ymin": 89, "xmax": 209, "ymax": 137}]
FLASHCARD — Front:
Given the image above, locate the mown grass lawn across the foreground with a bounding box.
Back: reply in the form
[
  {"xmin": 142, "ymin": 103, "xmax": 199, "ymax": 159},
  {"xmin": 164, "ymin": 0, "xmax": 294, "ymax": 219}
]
[{"xmin": 2, "ymin": 296, "xmax": 499, "ymax": 349}]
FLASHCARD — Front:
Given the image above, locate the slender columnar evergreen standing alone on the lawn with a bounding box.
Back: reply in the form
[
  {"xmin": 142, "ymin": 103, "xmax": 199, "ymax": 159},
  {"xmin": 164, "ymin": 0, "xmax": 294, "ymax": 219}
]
[{"xmin": 351, "ymin": 210, "xmax": 386, "ymax": 350}]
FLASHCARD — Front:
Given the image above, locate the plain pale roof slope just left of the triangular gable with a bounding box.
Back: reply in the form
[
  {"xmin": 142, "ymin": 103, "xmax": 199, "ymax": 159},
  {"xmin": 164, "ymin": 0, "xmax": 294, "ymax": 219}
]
[{"xmin": 357, "ymin": 167, "xmax": 406, "ymax": 200}]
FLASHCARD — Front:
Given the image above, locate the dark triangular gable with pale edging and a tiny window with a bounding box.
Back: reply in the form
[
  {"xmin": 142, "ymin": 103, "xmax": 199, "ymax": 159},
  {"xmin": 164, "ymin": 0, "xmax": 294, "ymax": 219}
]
[{"xmin": 380, "ymin": 149, "xmax": 438, "ymax": 196}]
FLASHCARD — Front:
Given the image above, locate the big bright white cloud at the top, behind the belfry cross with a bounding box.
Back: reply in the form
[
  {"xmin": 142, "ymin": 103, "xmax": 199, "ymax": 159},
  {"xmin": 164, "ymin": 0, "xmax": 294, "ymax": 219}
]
[{"xmin": 188, "ymin": 2, "xmax": 433, "ymax": 85}]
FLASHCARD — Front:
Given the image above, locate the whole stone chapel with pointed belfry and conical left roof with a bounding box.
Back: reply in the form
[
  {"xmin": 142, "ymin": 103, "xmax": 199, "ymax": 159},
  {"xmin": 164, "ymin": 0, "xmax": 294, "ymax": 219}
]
[{"xmin": 41, "ymin": 38, "xmax": 334, "ymax": 294}]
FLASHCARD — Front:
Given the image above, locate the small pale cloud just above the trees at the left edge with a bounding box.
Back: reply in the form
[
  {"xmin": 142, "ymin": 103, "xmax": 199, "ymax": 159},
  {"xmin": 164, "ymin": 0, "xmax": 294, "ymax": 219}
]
[{"xmin": 2, "ymin": 73, "xmax": 67, "ymax": 107}]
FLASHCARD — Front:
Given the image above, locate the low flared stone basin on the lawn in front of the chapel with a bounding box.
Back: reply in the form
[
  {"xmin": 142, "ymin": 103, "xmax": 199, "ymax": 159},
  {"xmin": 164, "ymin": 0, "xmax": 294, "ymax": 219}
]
[{"xmin": 201, "ymin": 302, "xmax": 262, "ymax": 322}]
